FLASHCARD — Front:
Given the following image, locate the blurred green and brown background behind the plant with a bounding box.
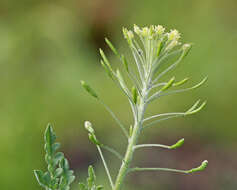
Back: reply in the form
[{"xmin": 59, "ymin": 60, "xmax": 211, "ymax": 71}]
[{"xmin": 0, "ymin": 0, "xmax": 237, "ymax": 190}]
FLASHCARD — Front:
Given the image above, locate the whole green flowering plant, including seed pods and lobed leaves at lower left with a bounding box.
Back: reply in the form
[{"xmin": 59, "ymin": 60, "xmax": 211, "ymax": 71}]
[{"xmin": 35, "ymin": 25, "xmax": 208, "ymax": 190}]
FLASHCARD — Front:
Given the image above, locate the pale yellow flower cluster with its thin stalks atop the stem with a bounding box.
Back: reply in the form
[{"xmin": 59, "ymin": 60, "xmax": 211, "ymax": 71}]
[{"xmin": 123, "ymin": 25, "xmax": 191, "ymax": 84}]
